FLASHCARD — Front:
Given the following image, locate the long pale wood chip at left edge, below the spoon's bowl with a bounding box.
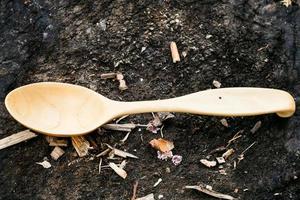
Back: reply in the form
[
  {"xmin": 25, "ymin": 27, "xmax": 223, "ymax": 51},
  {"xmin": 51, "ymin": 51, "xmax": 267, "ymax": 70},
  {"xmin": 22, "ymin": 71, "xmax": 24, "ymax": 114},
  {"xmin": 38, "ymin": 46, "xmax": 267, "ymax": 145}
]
[{"xmin": 0, "ymin": 130, "xmax": 37, "ymax": 150}]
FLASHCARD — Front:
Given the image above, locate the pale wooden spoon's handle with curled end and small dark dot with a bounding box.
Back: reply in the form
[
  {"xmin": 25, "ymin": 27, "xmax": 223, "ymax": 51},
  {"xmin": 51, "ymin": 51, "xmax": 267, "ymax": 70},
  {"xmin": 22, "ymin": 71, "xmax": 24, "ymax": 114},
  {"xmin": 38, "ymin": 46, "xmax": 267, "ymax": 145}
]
[{"xmin": 115, "ymin": 87, "xmax": 296, "ymax": 117}]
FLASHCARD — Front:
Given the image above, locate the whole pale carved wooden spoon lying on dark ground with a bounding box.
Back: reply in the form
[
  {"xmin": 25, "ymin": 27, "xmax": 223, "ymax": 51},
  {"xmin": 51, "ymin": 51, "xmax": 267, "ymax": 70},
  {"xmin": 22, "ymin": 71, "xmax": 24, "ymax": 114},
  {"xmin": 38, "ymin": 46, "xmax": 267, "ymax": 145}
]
[{"xmin": 5, "ymin": 82, "xmax": 295, "ymax": 136}]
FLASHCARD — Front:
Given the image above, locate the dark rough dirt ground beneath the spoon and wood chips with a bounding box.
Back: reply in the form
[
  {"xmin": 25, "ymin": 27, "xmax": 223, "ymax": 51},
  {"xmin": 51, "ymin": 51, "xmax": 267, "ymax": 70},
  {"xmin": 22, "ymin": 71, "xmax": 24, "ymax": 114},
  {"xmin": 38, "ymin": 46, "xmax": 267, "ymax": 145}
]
[{"xmin": 0, "ymin": 0, "xmax": 300, "ymax": 200}]
